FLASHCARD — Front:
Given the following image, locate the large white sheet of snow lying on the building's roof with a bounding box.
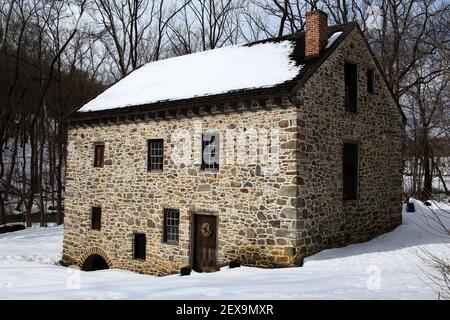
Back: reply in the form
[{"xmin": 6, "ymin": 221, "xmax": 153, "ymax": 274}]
[{"xmin": 78, "ymin": 40, "xmax": 302, "ymax": 112}]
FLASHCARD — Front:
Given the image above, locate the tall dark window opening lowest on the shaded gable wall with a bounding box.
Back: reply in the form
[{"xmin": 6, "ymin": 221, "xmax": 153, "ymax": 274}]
[{"xmin": 343, "ymin": 143, "xmax": 358, "ymax": 200}]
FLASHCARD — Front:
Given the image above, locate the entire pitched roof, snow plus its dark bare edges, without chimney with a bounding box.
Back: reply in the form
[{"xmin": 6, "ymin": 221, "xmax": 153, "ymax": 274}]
[{"xmin": 72, "ymin": 23, "xmax": 354, "ymax": 119}]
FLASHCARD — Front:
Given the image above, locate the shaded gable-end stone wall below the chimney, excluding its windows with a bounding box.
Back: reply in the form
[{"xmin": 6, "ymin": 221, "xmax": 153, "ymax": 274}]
[{"xmin": 297, "ymin": 29, "xmax": 403, "ymax": 256}]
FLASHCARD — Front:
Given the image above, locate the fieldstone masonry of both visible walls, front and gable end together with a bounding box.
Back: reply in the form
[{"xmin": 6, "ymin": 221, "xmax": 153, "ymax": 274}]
[{"xmin": 62, "ymin": 29, "xmax": 403, "ymax": 275}]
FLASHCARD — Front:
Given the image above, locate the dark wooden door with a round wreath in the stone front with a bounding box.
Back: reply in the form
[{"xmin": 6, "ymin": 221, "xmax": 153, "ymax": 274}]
[{"xmin": 193, "ymin": 215, "xmax": 217, "ymax": 272}]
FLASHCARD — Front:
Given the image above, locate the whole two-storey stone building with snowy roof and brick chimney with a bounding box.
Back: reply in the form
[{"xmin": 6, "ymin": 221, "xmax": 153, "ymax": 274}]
[{"xmin": 62, "ymin": 11, "xmax": 405, "ymax": 275}]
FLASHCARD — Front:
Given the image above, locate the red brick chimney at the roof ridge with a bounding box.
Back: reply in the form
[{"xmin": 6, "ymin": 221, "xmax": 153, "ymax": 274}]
[{"xmin": 305, "ymin": 10, "xmax": 328, "ymax": 59}]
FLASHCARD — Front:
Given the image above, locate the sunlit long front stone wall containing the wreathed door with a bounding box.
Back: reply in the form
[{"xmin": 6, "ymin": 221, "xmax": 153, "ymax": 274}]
[{"xmin": 63, "ymin": 99, "xmax": 297, "ymax": 275}]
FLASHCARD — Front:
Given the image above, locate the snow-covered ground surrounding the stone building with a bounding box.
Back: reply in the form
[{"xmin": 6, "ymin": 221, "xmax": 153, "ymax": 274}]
[{"xmin": 0, "ymin": 202, "xmax": 450, "ymax": 299}]
